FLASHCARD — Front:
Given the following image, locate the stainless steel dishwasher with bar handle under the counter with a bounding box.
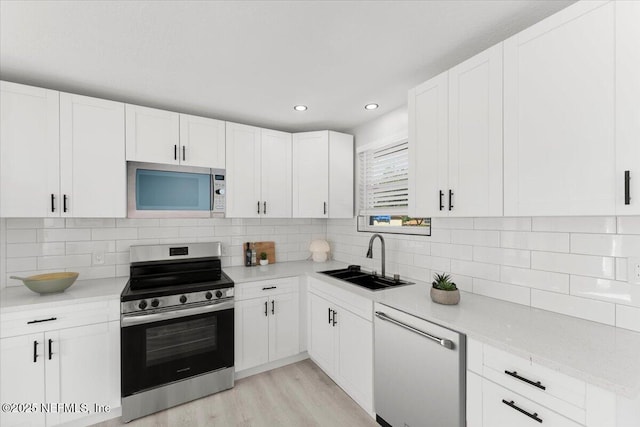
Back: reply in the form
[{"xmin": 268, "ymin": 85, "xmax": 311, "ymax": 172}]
[{"xmin": 374, "ymin": 303, "xmax": 466, "ymax": 427}]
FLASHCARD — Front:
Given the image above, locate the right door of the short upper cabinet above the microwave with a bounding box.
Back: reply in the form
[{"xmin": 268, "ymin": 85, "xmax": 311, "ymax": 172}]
[{"xmin": 179, "ymin": 114, "xmax": 225, "ymax": 169}]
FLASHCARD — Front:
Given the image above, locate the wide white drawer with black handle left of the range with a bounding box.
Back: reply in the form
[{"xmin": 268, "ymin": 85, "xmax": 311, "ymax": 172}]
[{"xmin": 0, "ymin": 300, "xmax": 115, "ymax": 338}]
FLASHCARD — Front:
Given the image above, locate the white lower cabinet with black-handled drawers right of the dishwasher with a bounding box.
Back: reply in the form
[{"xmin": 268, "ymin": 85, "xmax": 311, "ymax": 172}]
[{"xmin": 467, "ymin": 338, "xmax": 640, "ymax": 427}]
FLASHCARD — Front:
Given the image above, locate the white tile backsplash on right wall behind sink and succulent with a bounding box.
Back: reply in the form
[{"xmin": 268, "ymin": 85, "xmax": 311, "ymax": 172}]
[{"xmin": 327, "ymin": 216, "xmax": 640, "ymax": 332}]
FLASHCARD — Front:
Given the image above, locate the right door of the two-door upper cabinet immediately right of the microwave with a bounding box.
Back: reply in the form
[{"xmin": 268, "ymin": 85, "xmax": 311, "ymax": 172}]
[{"xmin": 260, "ymin": 129, "xmax": 292, "ymax": 218}]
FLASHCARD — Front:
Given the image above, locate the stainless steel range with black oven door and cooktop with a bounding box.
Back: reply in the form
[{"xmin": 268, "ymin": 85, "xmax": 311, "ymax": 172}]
[{"xmin": 120, "ymin": 242, "xmax": 234, "ymax": 422}]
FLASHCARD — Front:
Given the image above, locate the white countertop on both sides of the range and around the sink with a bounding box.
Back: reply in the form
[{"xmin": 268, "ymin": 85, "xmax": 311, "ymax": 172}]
[{"xmin": 0, "ymin": 261, "xmax": 640, "ymax": 397}]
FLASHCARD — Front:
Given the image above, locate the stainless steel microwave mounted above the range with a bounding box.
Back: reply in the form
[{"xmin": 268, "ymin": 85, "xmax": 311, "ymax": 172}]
[{"xmin": 127, "ymin": 162, "xmax": 226, "ymax": 218}]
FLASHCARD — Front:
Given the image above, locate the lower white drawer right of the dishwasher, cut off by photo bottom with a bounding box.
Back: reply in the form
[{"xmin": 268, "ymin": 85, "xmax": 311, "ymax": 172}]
[{"xmin": 482, "ymin": 379, "xmax": 581, "ymax": 427}]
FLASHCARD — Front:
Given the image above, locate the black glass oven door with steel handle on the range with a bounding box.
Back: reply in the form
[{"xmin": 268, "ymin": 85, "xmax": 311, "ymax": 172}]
[{"xmin": 121, "ymin": 300, "xmax": 234, "ymax": 397}]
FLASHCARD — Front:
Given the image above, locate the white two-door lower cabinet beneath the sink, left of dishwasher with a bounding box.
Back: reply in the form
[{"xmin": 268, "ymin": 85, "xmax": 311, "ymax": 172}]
[{"xmin": 308, "ymin": 278, "xmax": 374, "ymax": 415}]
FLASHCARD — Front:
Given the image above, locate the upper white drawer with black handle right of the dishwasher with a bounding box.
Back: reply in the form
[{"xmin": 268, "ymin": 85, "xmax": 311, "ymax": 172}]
[{"xmin": 483, "ymin": 345, "xmax": 586, "ymax": 423}]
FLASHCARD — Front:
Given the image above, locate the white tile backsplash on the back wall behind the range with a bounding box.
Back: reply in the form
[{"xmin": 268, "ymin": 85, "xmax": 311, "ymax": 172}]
[{"xmin": 0, "ymin": 218, "xmax": 326, "ymax": 288}]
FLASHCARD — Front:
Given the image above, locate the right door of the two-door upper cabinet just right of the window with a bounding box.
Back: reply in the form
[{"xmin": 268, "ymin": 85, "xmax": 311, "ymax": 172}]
[{"xmin": 447, "ymin": 43, "xmax": 502, "ymax": 217}]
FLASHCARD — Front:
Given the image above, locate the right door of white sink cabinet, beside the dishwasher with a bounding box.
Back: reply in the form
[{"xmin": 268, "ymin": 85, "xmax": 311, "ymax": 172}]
[{"xmin": 335, "ymin": 308, "xmax": 373, "ymax": 412}]
